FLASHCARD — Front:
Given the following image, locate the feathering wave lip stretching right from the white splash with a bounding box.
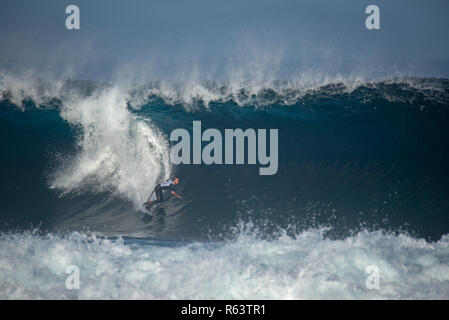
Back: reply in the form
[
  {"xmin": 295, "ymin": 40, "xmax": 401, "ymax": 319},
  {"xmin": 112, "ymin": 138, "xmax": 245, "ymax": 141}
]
[{"xmin": 122, "ymin": 77, "xmax": 449, "ymax": 109}]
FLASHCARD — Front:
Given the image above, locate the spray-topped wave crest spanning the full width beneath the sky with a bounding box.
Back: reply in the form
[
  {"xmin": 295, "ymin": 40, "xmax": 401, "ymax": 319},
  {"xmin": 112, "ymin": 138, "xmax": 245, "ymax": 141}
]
[{"xmin": 0, "ymin": 74, "xmax": 449, "ymax": 110}]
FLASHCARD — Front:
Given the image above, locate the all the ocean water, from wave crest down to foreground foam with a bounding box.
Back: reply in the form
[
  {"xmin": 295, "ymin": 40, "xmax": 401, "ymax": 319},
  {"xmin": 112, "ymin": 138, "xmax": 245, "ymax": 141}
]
[{"xmin": 0, "ymin": 76, "xmax": 449, "ymax": 299}]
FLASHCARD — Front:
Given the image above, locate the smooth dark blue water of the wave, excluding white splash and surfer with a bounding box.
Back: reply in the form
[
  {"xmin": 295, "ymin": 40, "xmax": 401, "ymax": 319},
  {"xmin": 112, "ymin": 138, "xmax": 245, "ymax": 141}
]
[{"xmin": 0, "ymin": 79, "xmax": 449, "ymax": 241}]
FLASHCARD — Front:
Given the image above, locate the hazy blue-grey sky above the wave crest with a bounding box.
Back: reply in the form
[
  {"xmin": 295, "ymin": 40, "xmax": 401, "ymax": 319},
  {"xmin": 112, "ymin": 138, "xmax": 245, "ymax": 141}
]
[{"xmin": 0, "ymin": 0, "xmax": 449, "ymax": 79}]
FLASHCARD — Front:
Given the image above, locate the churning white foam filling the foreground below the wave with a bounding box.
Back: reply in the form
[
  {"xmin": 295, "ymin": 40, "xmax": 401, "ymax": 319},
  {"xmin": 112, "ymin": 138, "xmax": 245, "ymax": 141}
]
[{"xmin": 0, "ymin": 230, "xmax": 449, "ymax": 299}]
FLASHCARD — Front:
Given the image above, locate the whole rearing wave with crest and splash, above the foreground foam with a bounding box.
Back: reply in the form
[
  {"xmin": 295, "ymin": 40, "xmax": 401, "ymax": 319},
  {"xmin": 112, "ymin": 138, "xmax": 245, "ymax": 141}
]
[{"xmin": 0, "ymin": 79, "xmax": 449, "ymax": 240}]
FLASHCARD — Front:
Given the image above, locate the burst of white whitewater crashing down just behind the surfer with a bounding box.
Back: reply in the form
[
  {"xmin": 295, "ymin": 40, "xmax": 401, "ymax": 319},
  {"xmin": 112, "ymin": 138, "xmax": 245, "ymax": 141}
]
[{"xmin": 51, "ymin": 87, "xmax": 171, "ymax": 205}]
